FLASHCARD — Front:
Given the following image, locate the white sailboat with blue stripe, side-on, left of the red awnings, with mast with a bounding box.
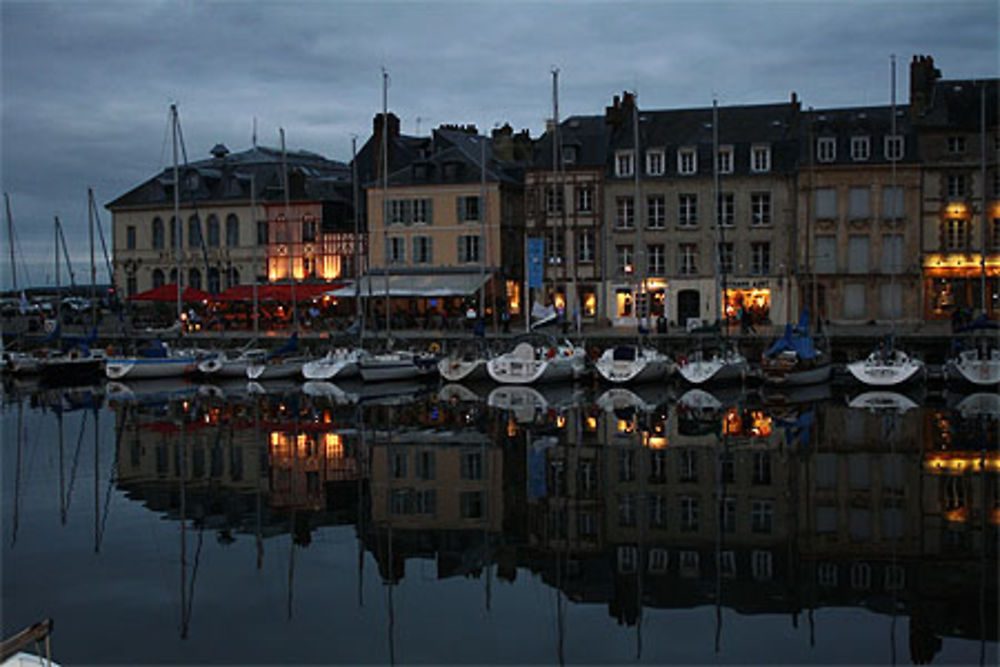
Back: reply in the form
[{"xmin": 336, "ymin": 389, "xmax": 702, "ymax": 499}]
[{"xmin": 104, "ymin": 104, "xmax": 204, "ymax": 380}]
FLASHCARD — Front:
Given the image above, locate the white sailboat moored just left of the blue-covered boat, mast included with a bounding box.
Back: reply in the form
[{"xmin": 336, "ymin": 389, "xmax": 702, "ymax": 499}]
[{"xmin": 677, "ymin": 100, "xmax": 749, "ymax": 385}]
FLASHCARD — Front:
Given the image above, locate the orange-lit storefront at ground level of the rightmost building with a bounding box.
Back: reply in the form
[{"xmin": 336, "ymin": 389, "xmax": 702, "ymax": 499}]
[{"xmin": 924, "ymin": 253, "xmax": 1000, "ymax": 319}]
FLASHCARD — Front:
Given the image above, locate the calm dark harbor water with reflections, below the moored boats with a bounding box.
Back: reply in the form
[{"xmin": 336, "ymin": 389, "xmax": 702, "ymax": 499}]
[{"xmin": 2, "ymin": 382, "xmax": 1000, "ymax": 665}]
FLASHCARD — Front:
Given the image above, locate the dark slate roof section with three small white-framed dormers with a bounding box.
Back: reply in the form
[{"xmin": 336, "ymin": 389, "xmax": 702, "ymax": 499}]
[{"xmin": 799, "ymin": 104, "xmax": 919, "ymax": 169}]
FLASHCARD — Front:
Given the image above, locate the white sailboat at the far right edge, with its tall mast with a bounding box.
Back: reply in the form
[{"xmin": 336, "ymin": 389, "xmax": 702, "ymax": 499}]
[{"xmin": 945, "ymin": 87, "xmax": 1000, "ymax": 387}]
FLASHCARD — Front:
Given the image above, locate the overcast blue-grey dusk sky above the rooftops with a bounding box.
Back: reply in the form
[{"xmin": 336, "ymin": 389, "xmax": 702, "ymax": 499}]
[{"xmin": 0, "ymin": 0, "xmax": 1000, "ymax": 286}]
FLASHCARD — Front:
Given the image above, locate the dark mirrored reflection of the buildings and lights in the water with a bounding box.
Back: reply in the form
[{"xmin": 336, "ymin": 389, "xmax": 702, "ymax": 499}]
[{"xmin": 95, "ymin": 380, "xmax": 1000, "ymax": 662}]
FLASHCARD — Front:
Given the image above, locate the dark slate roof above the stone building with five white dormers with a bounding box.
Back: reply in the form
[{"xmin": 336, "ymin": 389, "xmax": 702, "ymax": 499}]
[{"xmin": 607, "ymin": 102, "xmax": 799, "ymax": 178}]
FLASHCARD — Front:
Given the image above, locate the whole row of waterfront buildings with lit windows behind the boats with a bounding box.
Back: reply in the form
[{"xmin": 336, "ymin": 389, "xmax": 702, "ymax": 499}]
[{"xmin": 108, "ymin": 56, "xmax": 1000, "ymax": 326}]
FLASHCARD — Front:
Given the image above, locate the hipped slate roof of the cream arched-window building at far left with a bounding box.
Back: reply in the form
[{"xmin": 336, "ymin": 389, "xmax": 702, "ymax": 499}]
[{"xmin": 105, "ymin": 146, "xmax": 351, "ymax": 211}]
